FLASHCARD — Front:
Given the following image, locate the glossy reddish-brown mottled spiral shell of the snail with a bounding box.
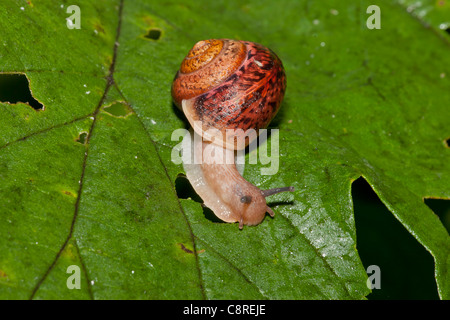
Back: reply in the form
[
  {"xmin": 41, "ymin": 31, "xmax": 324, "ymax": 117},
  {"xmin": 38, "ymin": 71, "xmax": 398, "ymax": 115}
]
[{"xmin": 172, "ymin": 39, "xmax": 286, "ymax": 149}]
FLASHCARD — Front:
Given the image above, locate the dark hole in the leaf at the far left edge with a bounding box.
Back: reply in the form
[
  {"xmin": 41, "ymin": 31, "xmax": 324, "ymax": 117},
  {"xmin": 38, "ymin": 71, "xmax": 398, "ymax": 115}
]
[{"xmin": 0, "ymin": 73, "xmax": 44, "ymax": 111}]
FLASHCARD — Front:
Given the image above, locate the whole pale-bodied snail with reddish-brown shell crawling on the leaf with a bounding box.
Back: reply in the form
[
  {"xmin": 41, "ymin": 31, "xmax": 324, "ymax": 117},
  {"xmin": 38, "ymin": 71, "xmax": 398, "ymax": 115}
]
[{"xmin": 172, "ymin": 39, "xmax": 294, "ymax": 229}]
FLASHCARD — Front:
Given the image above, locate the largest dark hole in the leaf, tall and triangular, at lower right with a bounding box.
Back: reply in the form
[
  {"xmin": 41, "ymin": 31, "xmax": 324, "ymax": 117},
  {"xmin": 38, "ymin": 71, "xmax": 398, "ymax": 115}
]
[{"xmin": 352, "ymin": 178, "xmax": 439, "ymax": 300}]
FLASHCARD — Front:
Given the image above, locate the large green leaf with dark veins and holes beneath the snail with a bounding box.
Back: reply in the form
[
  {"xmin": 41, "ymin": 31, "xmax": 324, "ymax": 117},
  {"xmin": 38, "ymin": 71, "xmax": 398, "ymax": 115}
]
[{"xmin": 0, "ymin": 0, "xmax": 450, "ymax": 299}]
